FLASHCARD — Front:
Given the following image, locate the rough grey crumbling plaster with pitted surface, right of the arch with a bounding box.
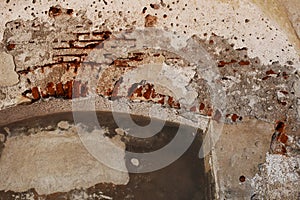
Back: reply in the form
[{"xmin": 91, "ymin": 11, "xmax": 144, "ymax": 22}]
[{"xmin": 195, "ymin": 35, "xmax": 299, "ymax": 130}]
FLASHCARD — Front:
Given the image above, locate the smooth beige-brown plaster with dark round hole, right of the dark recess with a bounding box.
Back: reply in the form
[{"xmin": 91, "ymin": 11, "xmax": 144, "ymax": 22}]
[{"xmin": 214, "ymin": 116, "xmax": 273, "ymax": 199}]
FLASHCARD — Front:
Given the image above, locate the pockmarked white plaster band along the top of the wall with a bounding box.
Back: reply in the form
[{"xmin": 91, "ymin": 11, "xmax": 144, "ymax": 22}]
[{"xmin": 0, "ymin": 0, "xmax": 299, "ymax": 68}]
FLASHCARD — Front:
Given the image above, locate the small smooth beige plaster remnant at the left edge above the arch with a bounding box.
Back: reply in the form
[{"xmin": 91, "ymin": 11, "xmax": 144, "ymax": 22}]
[{"xmin": 0, "ymin": 52, "xmax": 19, "ymax": 87}]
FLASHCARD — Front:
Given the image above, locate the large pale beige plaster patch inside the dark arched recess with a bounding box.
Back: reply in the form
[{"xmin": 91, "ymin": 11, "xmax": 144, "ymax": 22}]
[{"xmin": 0, "ymin": 122, "xmax": 129, "ymax": 194}]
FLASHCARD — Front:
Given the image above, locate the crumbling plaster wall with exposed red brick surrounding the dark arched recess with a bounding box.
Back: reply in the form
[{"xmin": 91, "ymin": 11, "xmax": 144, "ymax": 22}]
[{"xmin": 0, "ymin": 0, "xmax": 300, "ymax": 199}]
